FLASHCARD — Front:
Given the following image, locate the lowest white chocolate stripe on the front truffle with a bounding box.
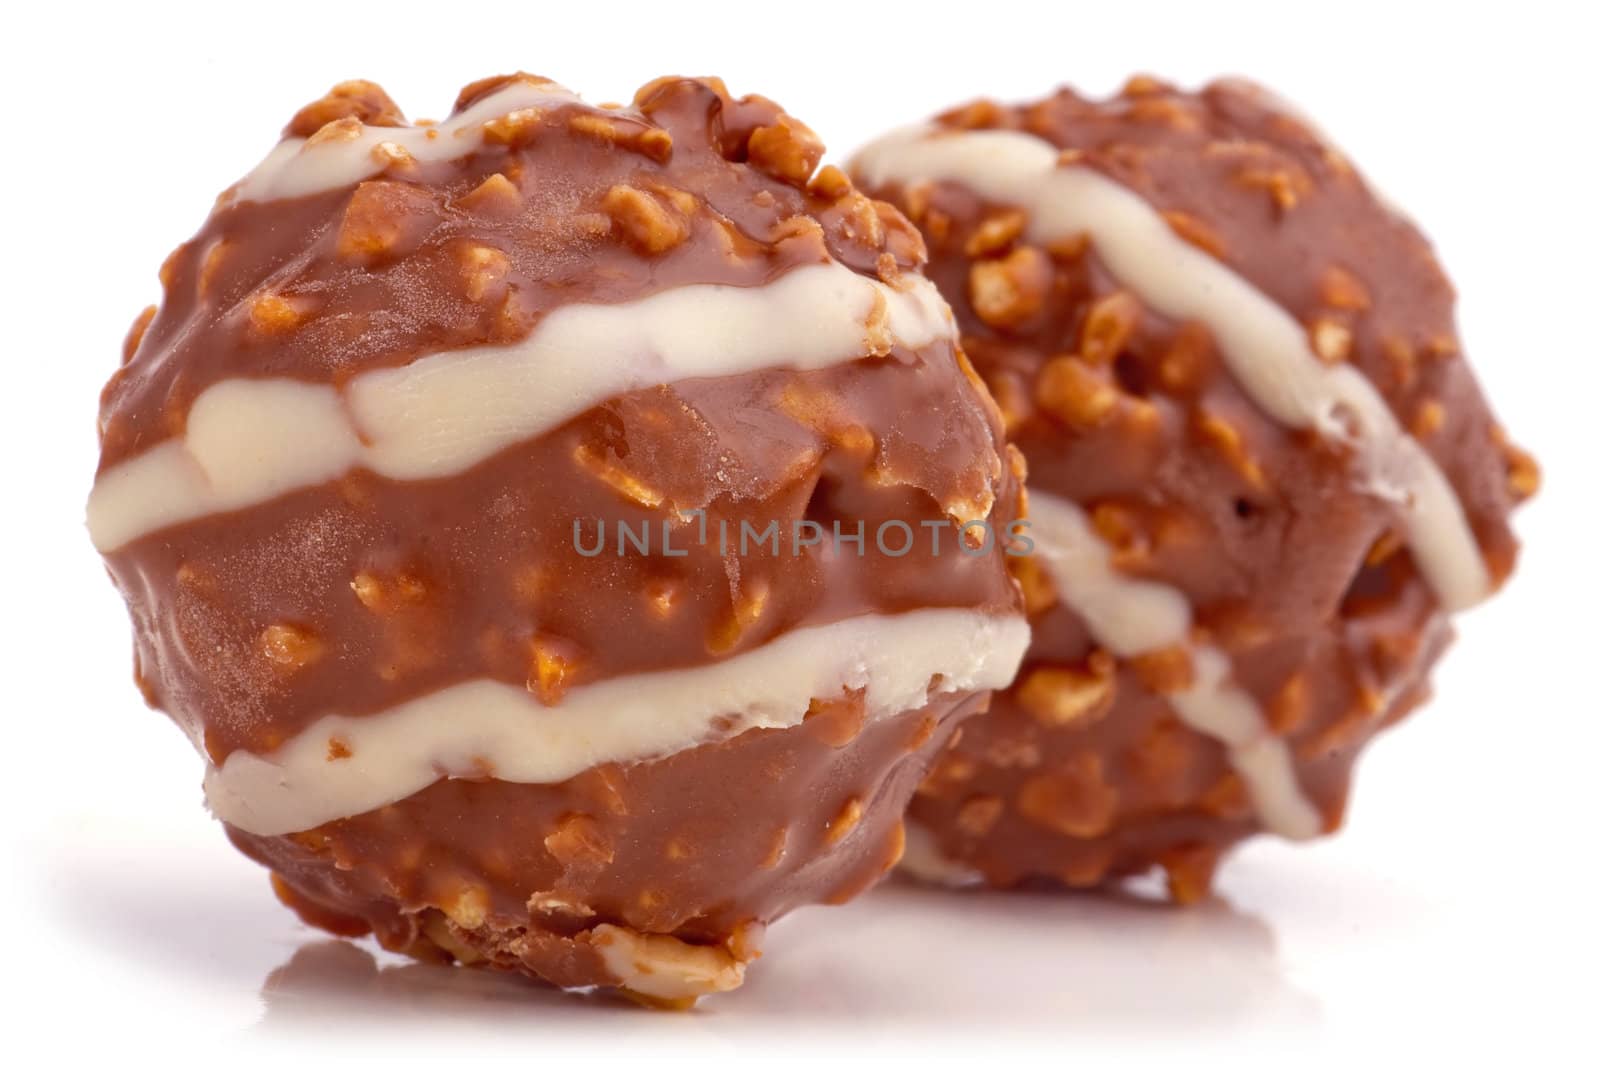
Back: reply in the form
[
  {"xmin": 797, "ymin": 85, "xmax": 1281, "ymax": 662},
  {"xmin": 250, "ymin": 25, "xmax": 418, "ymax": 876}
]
[{"xmin": 205, "ymin": 608, "xmax": 1029, "ymax": 833}]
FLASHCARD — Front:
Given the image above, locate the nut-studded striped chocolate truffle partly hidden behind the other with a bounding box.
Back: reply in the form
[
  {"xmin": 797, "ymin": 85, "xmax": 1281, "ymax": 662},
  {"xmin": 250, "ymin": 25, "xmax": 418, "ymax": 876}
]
[{"xmin": 853, "ymin": 77, "xmax": 1538, "ymax": 901}]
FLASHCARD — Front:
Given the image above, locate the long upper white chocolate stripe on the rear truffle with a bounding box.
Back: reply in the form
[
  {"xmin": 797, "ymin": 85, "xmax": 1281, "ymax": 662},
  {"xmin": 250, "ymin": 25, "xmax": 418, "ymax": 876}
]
[{"xmin": 853, "ymin": 126, "xmax": 1491, "ymax": 611}]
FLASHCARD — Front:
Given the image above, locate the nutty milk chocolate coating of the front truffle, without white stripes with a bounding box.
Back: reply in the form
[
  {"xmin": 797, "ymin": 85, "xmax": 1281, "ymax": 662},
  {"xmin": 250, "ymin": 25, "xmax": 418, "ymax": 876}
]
[{"xmin": 101, "ymin": 75, "xmax": 1021, "ymax": 1000}]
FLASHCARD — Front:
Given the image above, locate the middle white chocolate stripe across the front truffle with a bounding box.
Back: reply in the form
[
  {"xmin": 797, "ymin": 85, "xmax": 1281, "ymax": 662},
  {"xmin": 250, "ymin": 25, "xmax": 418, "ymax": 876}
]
[{"xmin": 88, "ymin": 262, "xmax": 954, "ymax": 552}]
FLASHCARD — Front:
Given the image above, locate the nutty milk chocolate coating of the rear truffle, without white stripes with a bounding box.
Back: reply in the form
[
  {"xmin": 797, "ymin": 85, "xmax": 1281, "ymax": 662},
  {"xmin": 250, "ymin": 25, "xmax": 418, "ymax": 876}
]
[{"xmin": 867, "ymin": 78, "xmax": 1538, "ymax": 901}]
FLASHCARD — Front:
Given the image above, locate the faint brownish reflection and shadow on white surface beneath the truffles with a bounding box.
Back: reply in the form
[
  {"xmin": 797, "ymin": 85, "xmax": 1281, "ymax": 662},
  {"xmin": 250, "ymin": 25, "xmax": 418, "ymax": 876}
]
[{"xmin": 53, "ymin": 827, "xmax": 1318, "ymax": 1040}]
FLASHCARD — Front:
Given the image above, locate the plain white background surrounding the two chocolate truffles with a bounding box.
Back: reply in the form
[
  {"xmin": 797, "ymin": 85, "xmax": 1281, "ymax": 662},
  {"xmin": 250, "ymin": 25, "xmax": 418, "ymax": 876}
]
[{"xmin": 0, "ymin": 0, "xmax": 1600, "ymax": 1062}]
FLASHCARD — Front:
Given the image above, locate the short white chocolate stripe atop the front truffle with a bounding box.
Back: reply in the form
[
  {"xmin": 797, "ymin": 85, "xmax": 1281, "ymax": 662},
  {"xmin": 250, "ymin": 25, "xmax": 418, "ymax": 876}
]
[{"xmin": 234, "ymin": 82, "xmax": 582, "ymax": 200}]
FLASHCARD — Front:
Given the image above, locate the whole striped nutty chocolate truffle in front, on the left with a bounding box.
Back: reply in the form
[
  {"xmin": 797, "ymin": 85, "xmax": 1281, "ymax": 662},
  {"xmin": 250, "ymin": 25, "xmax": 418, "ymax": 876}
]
[{"xmin": 90, "ymin": 75, "xmax": 1027, "ymax": 1003}]
